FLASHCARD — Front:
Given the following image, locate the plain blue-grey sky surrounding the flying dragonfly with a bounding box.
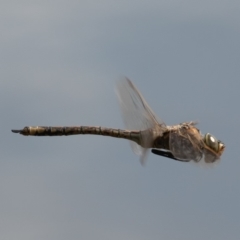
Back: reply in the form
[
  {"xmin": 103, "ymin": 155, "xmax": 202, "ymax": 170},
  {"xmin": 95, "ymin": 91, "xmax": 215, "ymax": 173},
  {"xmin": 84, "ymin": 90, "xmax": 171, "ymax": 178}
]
[{"xmin": 0, "ymin": 0, "xmax": 240, "ymax": 240}]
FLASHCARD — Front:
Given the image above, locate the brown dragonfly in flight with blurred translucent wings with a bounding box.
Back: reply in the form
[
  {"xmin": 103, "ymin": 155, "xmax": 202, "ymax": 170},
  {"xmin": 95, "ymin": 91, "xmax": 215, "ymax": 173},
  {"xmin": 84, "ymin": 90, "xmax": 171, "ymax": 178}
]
[{"xmin": 12, "ymin": 78, "xmax": 225, "ymax": 164}]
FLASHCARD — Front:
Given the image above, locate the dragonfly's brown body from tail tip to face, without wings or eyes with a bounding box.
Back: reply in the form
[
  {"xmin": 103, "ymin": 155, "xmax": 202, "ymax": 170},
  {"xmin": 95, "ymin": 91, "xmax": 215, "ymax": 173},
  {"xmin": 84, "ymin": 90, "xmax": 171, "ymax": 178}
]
[{"xmin": 12, "ymin": 122, "xmax": 224, "ymax": 162}]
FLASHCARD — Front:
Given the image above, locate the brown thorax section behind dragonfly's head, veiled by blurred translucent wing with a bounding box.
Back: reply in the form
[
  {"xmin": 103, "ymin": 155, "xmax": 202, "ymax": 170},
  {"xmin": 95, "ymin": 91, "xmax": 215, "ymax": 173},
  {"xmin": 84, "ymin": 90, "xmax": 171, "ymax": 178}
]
[{"xmin": 169, "ymin": 123, "xmax": 204, "ymax": 162}]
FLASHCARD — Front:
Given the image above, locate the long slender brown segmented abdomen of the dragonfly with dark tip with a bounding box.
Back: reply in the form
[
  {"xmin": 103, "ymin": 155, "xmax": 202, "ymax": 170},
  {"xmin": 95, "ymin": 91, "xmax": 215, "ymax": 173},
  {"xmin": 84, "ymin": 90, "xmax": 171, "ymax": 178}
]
[{"xmin": 12, "ymin": 126, "xmax": 141, "ymax": 144}]
